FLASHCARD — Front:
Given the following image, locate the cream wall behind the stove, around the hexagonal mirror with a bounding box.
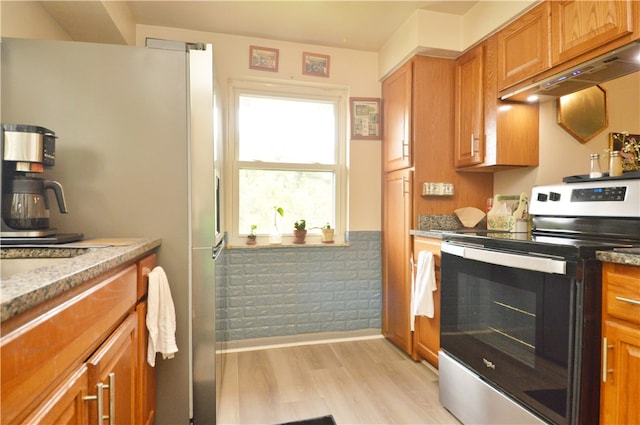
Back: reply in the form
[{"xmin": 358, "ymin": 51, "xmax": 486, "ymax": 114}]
[{"xmin": 493, "ymin": 72, "xmax": 640, "ymax": 194}]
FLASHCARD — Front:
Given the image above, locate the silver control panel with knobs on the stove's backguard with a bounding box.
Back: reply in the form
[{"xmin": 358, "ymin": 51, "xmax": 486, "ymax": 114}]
[{"xmin": 529, "ymin": 179, "xmax": 640, "ymax": 218}]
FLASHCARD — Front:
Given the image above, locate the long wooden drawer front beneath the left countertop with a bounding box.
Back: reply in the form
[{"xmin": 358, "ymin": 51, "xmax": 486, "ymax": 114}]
[{"xmin": 0, "ymin": 265, "xmax": 136, "ymax": 424}]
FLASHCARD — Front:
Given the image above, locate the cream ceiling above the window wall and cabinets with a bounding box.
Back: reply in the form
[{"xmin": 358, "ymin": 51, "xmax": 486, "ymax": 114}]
[{"xmin": 41, "ymin": 0, "xmax": 478, "ymax": 51}]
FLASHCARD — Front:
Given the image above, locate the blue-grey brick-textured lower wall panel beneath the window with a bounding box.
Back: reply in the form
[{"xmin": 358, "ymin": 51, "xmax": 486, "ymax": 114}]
[{"xmin": 216, "ymin": 232, "xmax": 382, "ymax": 341}]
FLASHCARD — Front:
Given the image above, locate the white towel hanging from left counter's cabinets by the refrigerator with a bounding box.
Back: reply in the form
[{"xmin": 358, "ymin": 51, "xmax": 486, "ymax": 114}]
[{"xmin": 147, "ymin": 266, "xmax": 178, "ymax": 366}]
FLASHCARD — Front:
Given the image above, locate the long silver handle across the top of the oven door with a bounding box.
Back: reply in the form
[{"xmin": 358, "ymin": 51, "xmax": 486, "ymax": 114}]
[{"xmin": 441, "ymin": 242, "xmax": 567, "ymax": 275}]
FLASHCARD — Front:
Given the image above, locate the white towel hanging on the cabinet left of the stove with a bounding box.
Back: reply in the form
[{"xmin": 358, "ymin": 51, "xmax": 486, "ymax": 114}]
[{"xmin": 411, "ymin": 251, "xmax": 437, "ymax": 331}]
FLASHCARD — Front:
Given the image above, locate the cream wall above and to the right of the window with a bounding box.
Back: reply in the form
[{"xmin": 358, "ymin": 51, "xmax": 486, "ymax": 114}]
[{"xmin": 136, "ymin": 25, "xmax": 381, "ymax": 231}]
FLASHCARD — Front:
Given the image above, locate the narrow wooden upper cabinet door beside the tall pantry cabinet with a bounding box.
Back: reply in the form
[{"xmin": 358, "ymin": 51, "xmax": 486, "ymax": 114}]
[{"xmin": 455, "ymin": 44, "xmax": 485, "ymax": 167}]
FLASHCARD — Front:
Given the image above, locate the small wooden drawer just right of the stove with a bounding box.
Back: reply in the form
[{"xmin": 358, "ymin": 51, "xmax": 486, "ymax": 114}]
[{"xmin": 604, "ymin": 264, "xmax": 640, "ymax": 324}]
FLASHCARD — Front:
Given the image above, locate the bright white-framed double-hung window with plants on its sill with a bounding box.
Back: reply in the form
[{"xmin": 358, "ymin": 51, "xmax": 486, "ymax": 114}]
[{"xmin": 230, "ymin": 81, "xmax": 348, "ymax": 244}]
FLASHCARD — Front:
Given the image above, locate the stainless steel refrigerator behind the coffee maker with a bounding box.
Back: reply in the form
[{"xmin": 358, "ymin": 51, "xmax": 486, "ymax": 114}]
[{"xmin": 0, "ymin": 38, "xmax": 221, "ymax": 424}]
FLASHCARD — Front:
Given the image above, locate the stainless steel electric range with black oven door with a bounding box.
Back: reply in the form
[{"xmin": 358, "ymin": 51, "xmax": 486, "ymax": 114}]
[{"xmin": 439, "ymin": 179, "xmax": 640, "ymax": 425}]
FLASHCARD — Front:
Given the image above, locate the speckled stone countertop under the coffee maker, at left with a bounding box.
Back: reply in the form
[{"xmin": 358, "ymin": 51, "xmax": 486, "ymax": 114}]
[{"xmin": 0, "ymin": 238, "xmax": 162, "ymax": 322}]
